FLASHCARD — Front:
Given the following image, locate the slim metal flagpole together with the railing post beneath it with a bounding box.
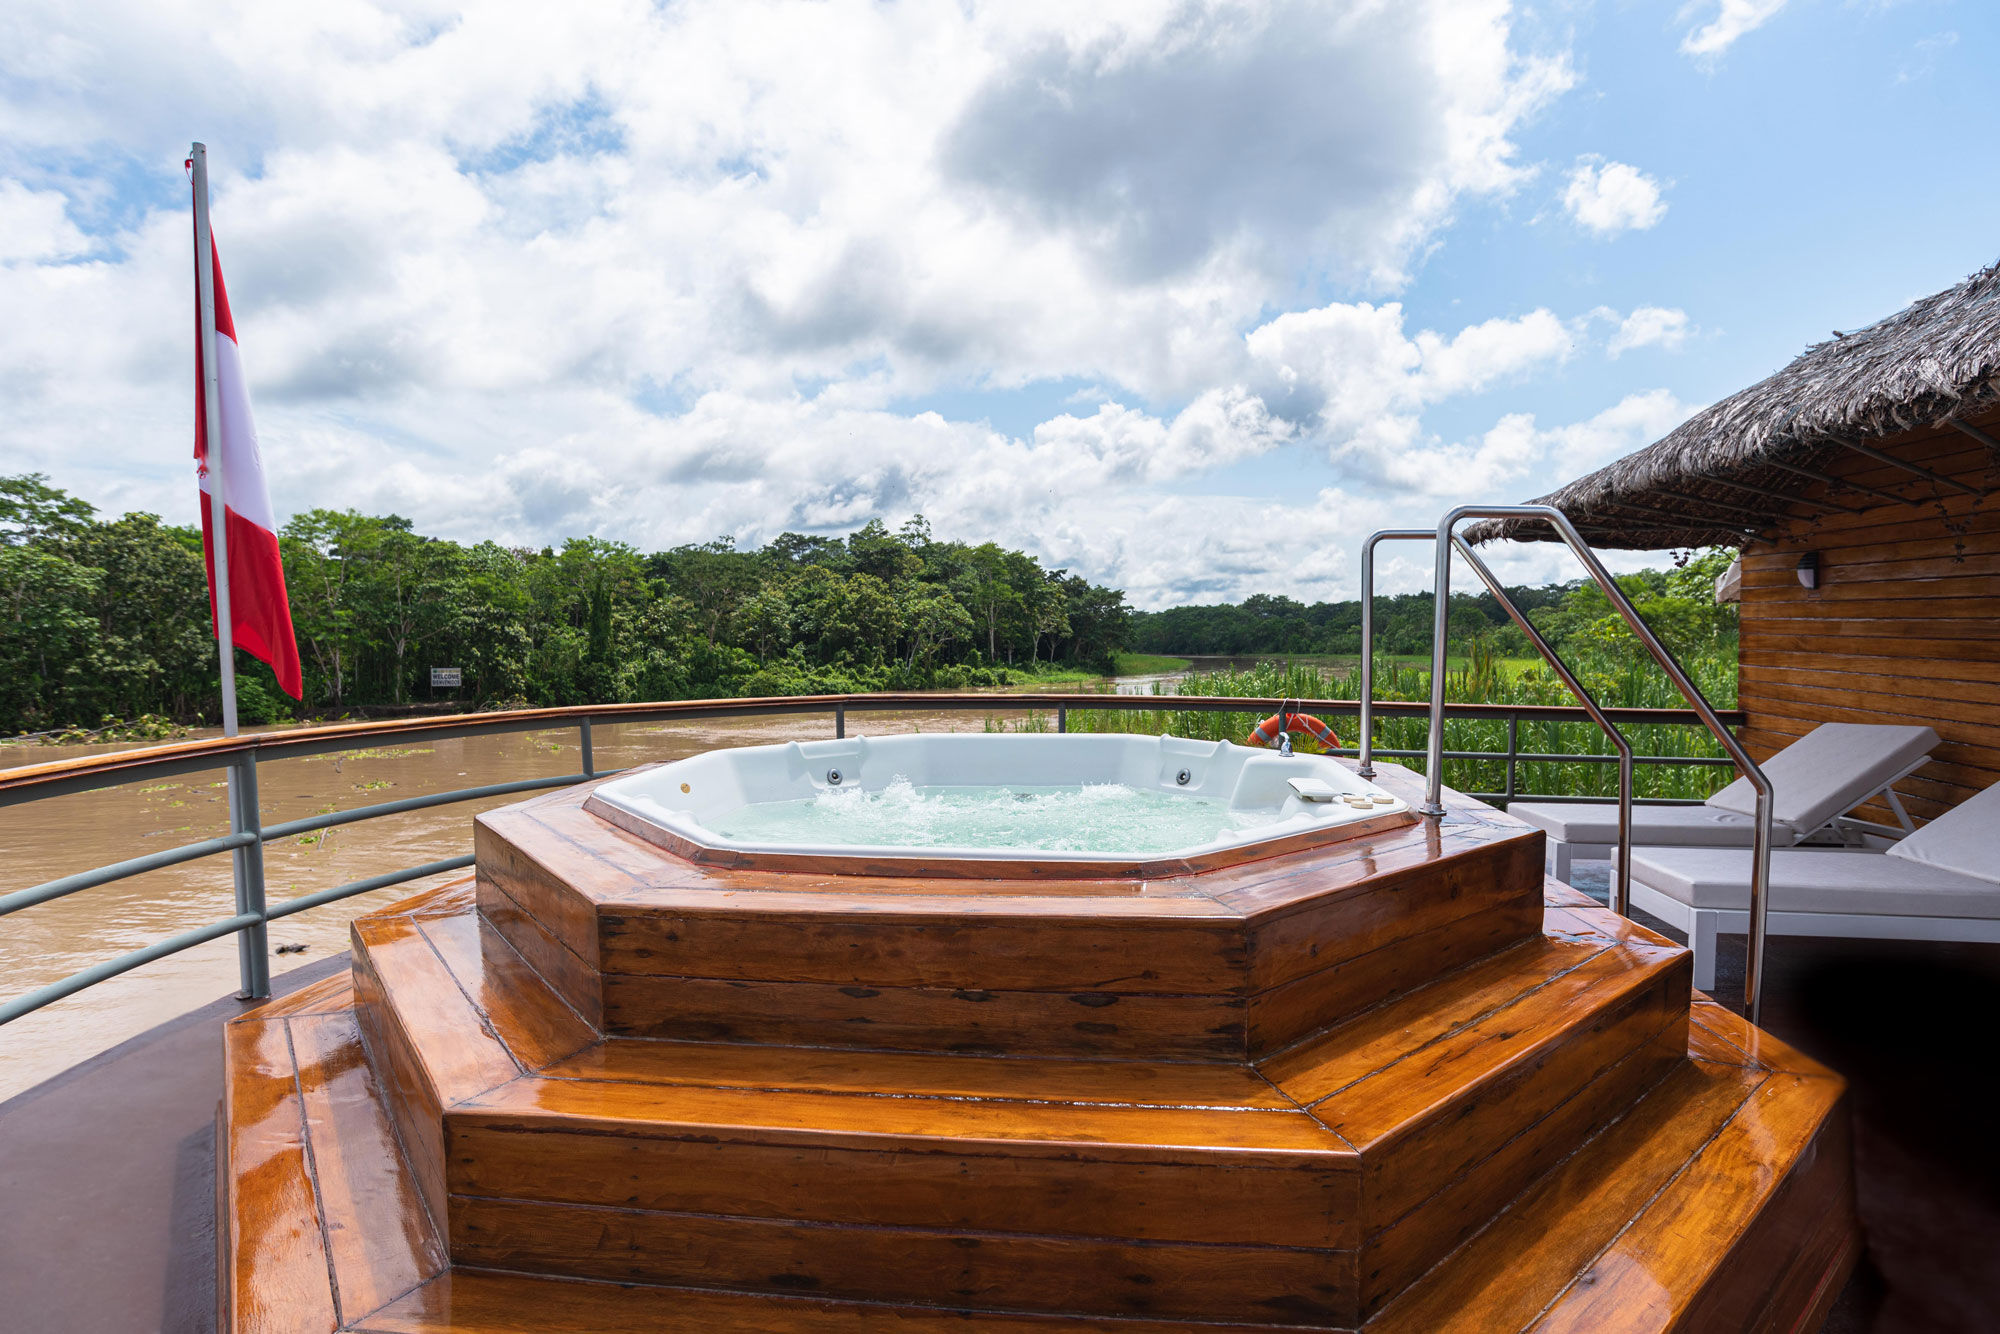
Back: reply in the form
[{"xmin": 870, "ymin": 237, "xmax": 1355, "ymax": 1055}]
[{"xmin": 188, "ymin": 144, "xmax": 270, "ymax": 1000}]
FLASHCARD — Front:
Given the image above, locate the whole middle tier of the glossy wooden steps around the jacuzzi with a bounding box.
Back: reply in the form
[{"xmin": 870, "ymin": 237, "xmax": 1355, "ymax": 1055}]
[{"xmin": 356, "ymin": 880, "xmax": 1688, "ymax": 1328}]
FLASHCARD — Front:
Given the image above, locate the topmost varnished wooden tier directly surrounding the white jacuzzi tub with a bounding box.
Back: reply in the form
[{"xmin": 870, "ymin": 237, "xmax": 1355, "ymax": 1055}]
[{"xmin": 476, "ymin": 766, "xmax": 1542, "ymax": 1062}]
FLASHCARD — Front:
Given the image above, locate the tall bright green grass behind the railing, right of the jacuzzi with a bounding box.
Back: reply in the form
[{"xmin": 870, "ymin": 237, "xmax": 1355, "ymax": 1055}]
[{"xmin": 1070, "ymin": 646, "xmax": 1736, "ymax": 798}]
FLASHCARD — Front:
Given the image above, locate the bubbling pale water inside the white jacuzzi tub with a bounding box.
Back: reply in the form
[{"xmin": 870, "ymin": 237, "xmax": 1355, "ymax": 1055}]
[{"xmin": 706, "ymin": 774, "xmax": 1270, "ymax": 854}]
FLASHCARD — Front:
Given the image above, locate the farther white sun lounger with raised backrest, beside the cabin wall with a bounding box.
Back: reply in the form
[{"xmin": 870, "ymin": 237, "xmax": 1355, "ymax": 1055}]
[{"xmin": 1508, "ymin": 722, "xmax": 1938, "ymax": 882}]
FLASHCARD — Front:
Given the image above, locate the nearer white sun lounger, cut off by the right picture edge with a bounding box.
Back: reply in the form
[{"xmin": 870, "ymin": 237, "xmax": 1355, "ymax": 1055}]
[{"xmin": 1632, "ymin": 786, "xmax": 2000, "ymax": 990}]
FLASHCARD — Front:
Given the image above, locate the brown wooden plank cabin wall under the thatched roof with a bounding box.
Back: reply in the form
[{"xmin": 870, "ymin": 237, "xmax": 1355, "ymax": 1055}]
[{"xmin": 1740, "ymin": 422, "xmax": 2000, "ymax": 822}]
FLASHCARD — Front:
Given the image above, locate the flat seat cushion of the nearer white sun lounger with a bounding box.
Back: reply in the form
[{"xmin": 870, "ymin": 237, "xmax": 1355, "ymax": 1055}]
[{"xmin": 1632, "ymin": 848, "xmax": 2000, "ymax": 918}]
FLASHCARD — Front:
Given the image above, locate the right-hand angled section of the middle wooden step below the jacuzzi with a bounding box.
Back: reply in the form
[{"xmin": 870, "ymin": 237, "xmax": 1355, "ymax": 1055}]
[{"xmin": 1258, "ymin": 936, "xmax": 1690, "ymax": 1316}]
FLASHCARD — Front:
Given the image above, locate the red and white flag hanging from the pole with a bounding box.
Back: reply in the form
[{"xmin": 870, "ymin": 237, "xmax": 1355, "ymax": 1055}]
[{"xmin": 194, "ymin": 236, "xmax": 304, "ymax": 700}]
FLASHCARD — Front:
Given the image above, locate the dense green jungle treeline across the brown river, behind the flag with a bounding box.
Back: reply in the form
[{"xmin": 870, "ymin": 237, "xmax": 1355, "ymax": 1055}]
[{"xmin": 0, "ymin": 474, "xmax": 1130, "ymax": 734}]
